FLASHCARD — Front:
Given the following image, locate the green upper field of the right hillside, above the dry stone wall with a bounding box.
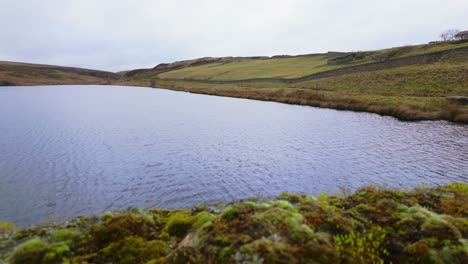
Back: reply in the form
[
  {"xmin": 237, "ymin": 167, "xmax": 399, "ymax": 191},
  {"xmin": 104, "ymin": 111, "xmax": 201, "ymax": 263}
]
[{"xmin": 125, "ymin": 42, "xmax": 468, "ymax": 81}]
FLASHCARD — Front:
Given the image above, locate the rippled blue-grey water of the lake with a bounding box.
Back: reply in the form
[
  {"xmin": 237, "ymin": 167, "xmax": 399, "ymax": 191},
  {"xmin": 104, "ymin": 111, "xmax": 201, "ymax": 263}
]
[{"xmin": 0, "ymin": 86, "xmax": 468, "ymax": 226}]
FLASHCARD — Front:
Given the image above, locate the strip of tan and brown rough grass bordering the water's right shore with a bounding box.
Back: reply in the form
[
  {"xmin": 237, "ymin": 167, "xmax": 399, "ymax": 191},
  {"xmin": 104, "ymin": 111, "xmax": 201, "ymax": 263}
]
[{"xmin": 118, "ymin": 78, "xmax": 468, "ymax": 124}]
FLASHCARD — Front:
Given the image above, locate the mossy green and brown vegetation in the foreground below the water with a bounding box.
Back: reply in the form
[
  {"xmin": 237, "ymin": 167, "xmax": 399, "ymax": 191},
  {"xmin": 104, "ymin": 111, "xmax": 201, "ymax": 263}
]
[{"xmin": 0, "ymin": 184, "xmax": 468, "ymax": 263}]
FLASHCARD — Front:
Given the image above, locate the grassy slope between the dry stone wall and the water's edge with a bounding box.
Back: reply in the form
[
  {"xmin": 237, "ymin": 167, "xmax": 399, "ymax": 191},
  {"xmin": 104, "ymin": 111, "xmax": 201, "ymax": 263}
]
[{"xmin": 118, "ymin": 56, "xmax": 468, "ymax": 124}]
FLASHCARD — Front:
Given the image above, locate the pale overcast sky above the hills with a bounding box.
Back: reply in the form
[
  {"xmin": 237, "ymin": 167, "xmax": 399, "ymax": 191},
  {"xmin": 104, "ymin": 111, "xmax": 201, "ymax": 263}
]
[{"xmin": 0, "ymin": 0, "xmax": 468, "ymax": 71}]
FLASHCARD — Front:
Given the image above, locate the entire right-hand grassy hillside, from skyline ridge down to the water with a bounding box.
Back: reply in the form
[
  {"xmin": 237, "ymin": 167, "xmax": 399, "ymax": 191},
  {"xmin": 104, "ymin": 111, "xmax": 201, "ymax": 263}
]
[{"xmin": 117, "ymin": 41, "xmax": 468, "ymax": 123}]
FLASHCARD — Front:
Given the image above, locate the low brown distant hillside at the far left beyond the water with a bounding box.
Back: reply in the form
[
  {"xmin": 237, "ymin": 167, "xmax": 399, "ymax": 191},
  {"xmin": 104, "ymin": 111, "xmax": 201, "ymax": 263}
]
[{"xmin": 0, "ymin": 61, "xmax": 120, "ymax": 86}]
